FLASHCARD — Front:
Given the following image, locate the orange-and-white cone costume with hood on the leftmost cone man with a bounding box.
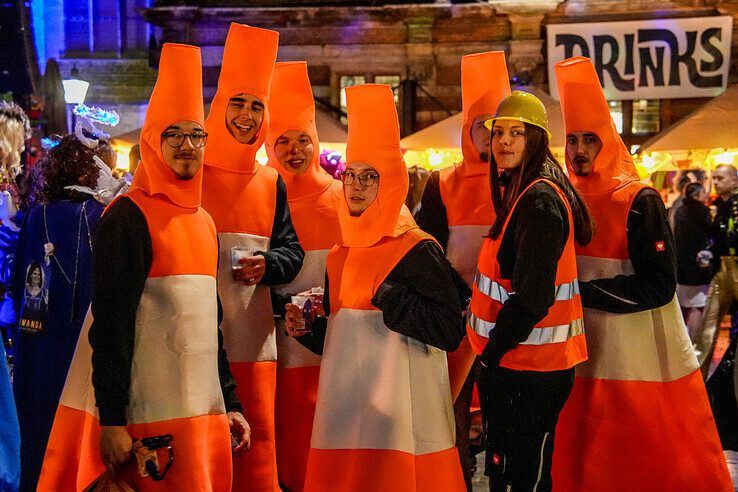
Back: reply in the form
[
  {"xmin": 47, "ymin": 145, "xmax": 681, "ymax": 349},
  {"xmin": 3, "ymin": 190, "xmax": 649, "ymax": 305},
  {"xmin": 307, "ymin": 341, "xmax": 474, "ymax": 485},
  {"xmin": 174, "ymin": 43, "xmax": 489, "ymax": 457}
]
[{"xmin": 38, "ymin": 44, "xmax": 231, "ymax": 492}]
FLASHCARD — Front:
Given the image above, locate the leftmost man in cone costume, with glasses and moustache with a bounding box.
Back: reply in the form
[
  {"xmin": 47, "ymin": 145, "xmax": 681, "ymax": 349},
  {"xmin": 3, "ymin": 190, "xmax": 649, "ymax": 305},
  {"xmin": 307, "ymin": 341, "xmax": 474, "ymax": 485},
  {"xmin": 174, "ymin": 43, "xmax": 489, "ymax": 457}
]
[{"xmin": 38, "ymin": 44, "xmax": 249, "ymax": 491}]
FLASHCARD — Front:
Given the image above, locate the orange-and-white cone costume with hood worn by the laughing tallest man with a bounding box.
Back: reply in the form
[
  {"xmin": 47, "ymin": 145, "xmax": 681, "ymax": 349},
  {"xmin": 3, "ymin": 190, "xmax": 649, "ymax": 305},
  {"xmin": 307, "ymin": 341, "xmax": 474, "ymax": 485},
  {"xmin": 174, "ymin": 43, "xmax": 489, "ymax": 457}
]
[{"xmin": 198, "ymin": 23, "xmax": 279, "ymax": 491}]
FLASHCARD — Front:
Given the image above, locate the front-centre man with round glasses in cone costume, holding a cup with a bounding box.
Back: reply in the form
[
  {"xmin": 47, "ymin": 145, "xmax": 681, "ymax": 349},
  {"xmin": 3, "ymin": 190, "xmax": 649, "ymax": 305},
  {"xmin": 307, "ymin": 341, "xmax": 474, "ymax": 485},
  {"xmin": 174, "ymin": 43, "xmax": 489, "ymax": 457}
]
[{"xmin": 286, "ymin": 84, "xmax": 466, "ymax": 491}]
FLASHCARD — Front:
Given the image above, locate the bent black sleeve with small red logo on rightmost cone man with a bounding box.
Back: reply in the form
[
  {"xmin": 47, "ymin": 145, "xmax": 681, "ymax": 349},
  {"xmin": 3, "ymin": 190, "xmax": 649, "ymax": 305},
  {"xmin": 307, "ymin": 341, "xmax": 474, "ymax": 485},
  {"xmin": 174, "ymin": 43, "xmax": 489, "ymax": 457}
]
[{"xmin": 579, "ymin": 189, "xmax": 676, "ymax": 313}]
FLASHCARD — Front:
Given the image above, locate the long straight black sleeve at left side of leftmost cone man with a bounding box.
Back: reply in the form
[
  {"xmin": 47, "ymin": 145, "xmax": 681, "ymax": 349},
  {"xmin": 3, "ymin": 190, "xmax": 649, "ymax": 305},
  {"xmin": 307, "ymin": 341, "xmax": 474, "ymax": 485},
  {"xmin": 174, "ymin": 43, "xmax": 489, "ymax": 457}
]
[{"xmin": 89, "ymin": 198, "xmax": 152, "ymax": 425}]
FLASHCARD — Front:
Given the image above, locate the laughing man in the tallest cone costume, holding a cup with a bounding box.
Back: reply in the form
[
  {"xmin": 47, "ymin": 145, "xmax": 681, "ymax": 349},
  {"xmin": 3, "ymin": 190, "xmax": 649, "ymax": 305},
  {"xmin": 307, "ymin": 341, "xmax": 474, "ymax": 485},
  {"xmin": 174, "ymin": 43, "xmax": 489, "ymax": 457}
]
[{"xmin": 202, "ymin": 23, "xmax": 303, "ymax": 491}]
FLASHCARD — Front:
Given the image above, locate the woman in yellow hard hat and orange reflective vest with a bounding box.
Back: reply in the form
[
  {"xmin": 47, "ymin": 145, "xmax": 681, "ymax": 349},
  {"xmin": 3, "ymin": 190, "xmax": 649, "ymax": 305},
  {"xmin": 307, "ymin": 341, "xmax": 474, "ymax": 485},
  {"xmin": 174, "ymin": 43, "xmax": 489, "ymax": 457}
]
[{"xmin": 467, "ymin": 91, "xmax": 593, "ymax": 491}]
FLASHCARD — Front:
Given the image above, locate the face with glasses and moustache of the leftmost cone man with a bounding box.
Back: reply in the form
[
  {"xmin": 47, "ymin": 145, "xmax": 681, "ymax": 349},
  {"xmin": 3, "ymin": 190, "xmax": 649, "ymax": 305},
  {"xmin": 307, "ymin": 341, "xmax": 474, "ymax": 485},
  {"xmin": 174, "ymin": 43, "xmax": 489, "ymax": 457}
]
[{"xmin": 161, "ymin": 121, "xmax": 206, "ymax": 180}]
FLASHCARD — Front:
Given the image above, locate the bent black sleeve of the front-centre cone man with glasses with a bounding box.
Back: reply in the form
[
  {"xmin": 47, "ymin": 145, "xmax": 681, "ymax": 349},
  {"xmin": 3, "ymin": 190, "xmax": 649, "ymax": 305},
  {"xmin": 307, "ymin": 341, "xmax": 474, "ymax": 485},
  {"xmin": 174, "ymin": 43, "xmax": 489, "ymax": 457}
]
[{"xmin": 372, "ymin": 240, "xmax": 465, "ymax": 352}]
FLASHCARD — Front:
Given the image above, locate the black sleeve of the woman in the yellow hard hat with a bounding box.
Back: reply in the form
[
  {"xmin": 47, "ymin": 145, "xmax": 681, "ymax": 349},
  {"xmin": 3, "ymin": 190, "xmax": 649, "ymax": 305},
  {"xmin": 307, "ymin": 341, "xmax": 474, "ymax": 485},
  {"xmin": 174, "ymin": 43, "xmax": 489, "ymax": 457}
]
[{"xmin": 481, "ymin": 188, "xmax": 570, "ymax": 367}]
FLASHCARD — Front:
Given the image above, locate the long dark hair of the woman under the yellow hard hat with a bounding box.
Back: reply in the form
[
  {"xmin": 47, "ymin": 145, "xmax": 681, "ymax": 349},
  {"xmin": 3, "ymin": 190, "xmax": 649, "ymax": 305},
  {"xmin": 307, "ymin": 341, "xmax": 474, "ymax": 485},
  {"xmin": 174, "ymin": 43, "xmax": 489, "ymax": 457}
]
[{"xmin": 488, "ymin": 123, "xmax": 594, "ymax": 246}]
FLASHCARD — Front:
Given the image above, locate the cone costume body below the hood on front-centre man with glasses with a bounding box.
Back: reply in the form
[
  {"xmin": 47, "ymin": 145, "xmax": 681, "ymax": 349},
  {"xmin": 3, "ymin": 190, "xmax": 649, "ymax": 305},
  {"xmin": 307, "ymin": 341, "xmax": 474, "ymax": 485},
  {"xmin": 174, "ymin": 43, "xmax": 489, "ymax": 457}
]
[{"xmin": 305, "ymin": 228, "xmax": 465, "ymax": 491}]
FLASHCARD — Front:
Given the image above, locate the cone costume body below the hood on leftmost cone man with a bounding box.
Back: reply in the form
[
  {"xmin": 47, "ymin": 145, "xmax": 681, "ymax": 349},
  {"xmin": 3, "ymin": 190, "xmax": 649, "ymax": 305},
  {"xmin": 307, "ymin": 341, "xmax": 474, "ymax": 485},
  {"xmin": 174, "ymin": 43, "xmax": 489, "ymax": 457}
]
[{"xmin": 38, "ymin": 188, "xmax": 231, "ymax": 492}]
